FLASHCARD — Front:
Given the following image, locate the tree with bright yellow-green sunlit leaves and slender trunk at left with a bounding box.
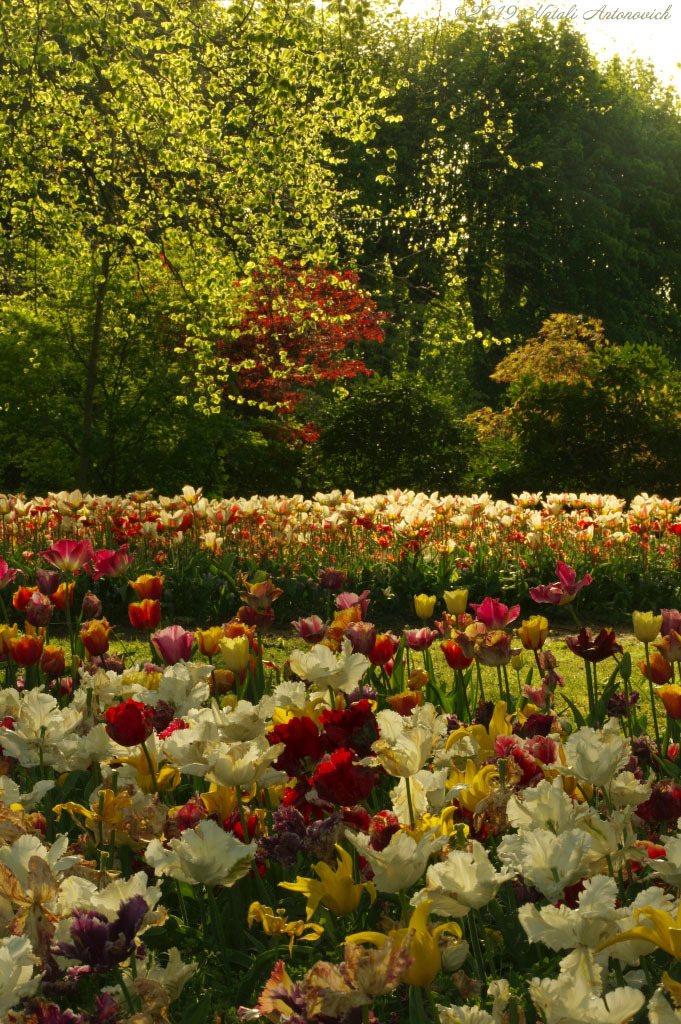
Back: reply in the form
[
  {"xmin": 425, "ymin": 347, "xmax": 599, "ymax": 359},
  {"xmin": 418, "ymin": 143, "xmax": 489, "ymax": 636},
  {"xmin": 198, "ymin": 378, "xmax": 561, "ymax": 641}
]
[{"xmin": 0, "ymin": 0, "xmax": 382, "ymax": 487}]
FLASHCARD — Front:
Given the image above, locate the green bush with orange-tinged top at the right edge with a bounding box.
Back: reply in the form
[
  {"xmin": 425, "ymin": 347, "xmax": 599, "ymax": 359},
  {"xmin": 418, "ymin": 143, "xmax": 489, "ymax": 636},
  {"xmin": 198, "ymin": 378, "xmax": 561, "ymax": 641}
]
[{"xmin": 476, "ymin": 316, "xmax": 681, "ymax": 498}]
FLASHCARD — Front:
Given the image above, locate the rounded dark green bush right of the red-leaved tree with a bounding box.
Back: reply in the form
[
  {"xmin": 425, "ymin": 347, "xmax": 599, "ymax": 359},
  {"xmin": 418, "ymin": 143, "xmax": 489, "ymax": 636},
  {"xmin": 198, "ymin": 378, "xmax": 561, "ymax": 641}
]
[{"xmin": 303, "ymin": 376, "xmax": 473, "ymax": 495}]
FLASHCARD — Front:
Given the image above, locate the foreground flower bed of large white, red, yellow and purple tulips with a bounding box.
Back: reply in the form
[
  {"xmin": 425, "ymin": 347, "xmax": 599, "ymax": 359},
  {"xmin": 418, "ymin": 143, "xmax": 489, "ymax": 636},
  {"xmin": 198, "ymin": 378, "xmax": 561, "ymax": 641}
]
[{"xmin": 0, "ymin": 539, "xmax": 681, "ymax": 1024}]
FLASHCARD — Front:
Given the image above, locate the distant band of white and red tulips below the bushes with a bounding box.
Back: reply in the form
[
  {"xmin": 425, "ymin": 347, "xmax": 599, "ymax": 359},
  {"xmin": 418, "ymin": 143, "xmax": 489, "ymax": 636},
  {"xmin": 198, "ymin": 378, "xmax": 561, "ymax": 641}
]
[{"xmin": 0, "ymin": 486, "xmax": 681, "ymax": 622}]
